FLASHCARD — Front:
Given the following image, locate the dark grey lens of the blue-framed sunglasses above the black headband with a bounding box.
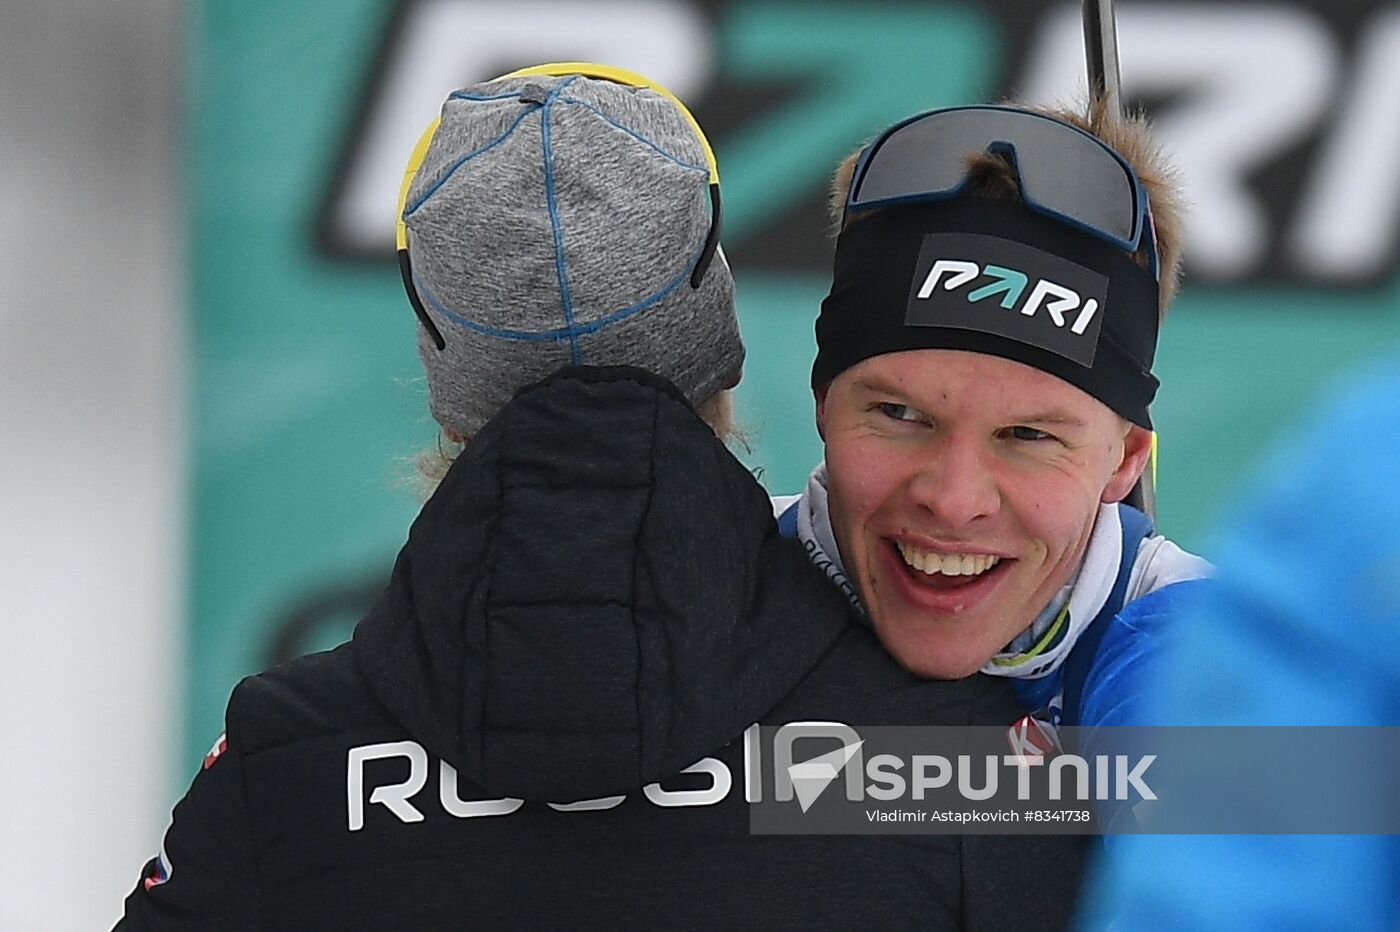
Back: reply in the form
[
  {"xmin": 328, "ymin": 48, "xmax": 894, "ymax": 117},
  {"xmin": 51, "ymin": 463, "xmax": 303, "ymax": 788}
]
[{"xmin": 851, "ymin": 109, "xmax": 1140, "ymax": 243}]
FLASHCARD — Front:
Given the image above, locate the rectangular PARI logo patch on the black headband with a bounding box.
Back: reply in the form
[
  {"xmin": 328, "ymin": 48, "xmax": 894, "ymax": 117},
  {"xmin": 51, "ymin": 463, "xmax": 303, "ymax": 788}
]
[{"xmin": 904, "ymin": 234, "xmax": 1109, "ymax": 368}]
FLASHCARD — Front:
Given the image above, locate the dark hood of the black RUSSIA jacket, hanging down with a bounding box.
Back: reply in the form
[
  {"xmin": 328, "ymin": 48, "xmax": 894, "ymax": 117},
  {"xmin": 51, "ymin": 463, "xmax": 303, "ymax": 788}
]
[{"xmin": 354, "ymin": 367, "xmax": 847, "ymax": 802}]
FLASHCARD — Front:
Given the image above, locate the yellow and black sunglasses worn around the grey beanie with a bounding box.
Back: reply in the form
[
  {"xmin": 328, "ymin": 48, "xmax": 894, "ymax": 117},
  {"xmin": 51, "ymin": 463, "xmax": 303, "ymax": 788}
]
[{"xmin": 395, "ymin": 62, "xmax": 721, "ymax": 350}]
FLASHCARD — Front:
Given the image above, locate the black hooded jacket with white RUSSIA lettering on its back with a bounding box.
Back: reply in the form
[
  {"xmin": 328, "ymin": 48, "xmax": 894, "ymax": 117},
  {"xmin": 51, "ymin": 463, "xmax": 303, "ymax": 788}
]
[{"xmin": 118, "ymin": 369, "xmax": 1085, "ymax": 931}]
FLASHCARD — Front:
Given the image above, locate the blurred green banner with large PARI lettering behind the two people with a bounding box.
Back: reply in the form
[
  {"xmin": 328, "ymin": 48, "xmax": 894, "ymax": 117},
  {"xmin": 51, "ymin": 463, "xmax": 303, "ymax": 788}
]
[{"xmin": 186, "ymin": 0, "xmax": 1400, "ymax": 754}]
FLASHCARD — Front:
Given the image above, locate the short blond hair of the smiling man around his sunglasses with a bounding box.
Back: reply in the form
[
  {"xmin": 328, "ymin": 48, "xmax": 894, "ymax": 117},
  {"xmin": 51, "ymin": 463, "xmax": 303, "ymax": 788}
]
[{"xmin": 830, "ymin": 99, "xmax": 1184, "ymax": 318}]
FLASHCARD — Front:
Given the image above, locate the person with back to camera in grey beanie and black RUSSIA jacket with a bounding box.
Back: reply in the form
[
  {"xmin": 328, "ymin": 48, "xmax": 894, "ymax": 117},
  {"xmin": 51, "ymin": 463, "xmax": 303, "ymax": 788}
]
[{"xmin": 118, "ymin": 63, "xmax": 1084, "ymax": 929}]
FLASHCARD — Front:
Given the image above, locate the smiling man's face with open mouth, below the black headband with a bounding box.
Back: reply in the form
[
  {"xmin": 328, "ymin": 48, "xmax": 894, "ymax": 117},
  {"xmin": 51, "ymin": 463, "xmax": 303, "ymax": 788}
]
[{"xmin": 816, "ymin": 350, "xmax": 1151, "ymax": 679}]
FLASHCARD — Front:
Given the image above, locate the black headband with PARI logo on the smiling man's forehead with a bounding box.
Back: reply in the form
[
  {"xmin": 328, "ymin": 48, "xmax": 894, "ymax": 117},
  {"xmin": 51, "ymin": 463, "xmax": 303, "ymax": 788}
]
[{"xmin": 812, "ymin": 197, "xmax": 1158, "ymax": 428}]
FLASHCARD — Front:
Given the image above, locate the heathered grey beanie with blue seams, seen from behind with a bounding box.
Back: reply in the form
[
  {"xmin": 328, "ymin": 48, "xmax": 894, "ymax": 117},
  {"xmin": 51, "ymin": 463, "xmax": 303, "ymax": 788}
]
[{"xmin": 403, "ymin": 76, "xmax": 743, "ymax": 437}]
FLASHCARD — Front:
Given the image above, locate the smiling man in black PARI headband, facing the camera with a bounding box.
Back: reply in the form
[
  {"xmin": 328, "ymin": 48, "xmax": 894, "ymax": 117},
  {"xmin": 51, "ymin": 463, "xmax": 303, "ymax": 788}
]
[{"xmin": 778, "ymin": 106, "xmax": 1208, "ymax": 725}]
